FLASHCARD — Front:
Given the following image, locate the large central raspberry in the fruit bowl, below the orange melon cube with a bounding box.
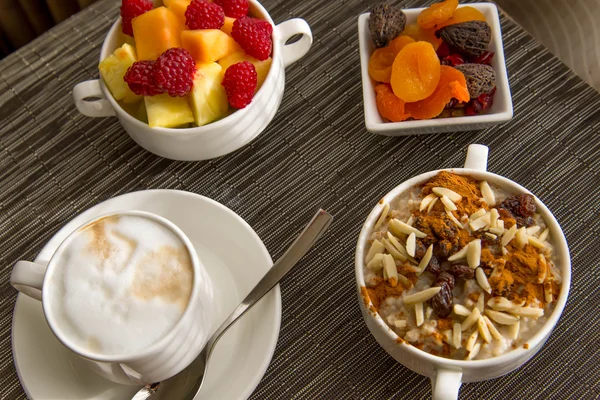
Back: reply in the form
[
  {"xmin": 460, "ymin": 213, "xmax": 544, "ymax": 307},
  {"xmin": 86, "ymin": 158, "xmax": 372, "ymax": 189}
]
[{"xmin": 154, "ymin": 47, "xmax": 196, "ymax": 97}]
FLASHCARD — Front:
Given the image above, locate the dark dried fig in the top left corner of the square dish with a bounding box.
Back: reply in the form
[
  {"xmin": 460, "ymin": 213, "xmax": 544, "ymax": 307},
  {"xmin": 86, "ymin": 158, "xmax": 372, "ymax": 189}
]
[{"xmin": 369, "ymin": 3, "xmax": 406, "ymax": 48}]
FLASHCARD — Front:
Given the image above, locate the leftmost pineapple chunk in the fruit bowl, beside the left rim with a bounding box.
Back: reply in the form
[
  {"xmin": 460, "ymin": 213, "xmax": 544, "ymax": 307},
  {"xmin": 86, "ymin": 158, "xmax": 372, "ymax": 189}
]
[{"xmin": 98, "ymin": 43, "xmax": 142, "ymax": 103}]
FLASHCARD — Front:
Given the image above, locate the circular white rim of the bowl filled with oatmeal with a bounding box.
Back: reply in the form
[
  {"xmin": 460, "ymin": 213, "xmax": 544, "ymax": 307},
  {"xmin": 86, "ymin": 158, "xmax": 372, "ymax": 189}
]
[{"xmin": 354, "ymin": 168, "xmax": 571, "ymax": 368}]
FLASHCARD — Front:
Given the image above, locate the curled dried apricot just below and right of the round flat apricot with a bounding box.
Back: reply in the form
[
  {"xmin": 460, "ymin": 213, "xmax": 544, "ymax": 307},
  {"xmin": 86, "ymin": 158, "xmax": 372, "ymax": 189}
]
[{"xmin": 405, "ymin": 65, "xmax": 470, "ymax": 119}]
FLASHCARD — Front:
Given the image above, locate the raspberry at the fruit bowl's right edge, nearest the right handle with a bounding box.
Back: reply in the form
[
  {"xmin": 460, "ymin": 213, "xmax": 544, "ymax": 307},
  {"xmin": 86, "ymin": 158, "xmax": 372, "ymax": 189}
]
[{"xmin": 231, "ymin": 17, "xmax": 273, "ymax": 61}]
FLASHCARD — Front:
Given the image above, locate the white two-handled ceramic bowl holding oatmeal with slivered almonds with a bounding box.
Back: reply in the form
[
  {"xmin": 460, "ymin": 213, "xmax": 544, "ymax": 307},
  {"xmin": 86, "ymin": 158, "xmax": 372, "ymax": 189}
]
[{"xmin": 354, "ymin": 144, "xmax": 571, "ymax": 400}]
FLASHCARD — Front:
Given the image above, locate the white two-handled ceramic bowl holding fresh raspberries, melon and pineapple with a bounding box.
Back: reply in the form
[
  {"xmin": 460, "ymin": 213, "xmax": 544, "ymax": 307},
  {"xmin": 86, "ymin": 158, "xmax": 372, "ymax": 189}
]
[{"xmin": 73, "ymin": 0, "xmax": 313, "ymax": 161}]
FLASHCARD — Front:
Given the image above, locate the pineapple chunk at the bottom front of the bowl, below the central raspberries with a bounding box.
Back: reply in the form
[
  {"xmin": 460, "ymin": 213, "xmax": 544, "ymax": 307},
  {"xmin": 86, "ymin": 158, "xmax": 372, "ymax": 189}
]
[{"xmin": 144, "ymin": 93, "xmax": 194, "ymax": 128}]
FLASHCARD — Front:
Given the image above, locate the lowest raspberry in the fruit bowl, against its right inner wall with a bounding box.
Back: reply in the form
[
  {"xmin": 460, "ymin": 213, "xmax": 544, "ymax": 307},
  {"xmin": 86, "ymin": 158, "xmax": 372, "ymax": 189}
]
[{"xmin": 222, "ymin": 61, "xmax": 257, "ymax": 109}]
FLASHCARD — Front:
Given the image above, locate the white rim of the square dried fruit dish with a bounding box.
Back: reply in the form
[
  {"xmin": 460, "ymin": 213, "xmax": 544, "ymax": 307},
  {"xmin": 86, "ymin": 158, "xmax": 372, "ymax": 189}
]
[{"xmin": 358, "ymin": 3, "xmax": 513, "ymax": 134}]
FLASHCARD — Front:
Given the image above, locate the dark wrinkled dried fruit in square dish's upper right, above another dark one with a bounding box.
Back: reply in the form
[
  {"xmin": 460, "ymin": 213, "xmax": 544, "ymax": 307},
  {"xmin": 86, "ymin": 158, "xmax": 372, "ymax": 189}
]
[{"xmin": 435, "ymin": 21, "xmax": 492, "ymax": 57}]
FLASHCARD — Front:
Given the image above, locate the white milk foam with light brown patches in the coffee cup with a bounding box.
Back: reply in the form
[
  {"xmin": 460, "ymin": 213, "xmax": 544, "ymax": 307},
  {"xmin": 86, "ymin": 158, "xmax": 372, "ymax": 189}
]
[{"xmin": 50, "ymin": 215, "xmax": 194, "ymax": 355}]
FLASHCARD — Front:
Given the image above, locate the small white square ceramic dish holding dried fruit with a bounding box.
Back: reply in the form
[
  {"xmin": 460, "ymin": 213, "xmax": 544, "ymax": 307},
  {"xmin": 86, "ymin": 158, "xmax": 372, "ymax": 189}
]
[{"xmin": 358, "ymin": 3, "xmax": 513, "ymax": 136}]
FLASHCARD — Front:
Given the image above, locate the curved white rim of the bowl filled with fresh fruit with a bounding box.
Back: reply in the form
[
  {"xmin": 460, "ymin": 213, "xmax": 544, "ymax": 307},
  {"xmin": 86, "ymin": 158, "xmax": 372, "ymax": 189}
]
[{"xmin": 98, "ymin": 0, "xmax": 282, "ymax": 137}]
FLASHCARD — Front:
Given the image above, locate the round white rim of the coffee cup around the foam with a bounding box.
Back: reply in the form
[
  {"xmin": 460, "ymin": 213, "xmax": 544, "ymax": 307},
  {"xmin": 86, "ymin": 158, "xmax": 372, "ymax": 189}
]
[{"xmin": 42, "ymin": 210, "xmax": 204, "ymax": 363}]
